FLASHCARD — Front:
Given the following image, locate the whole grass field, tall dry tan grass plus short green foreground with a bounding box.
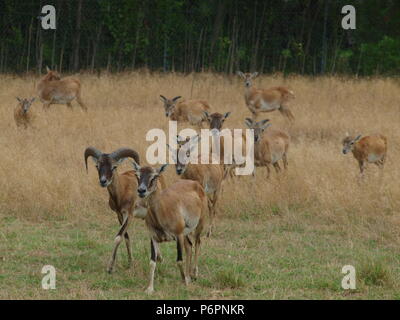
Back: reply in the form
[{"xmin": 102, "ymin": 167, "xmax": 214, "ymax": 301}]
[{"xmin": 0, "ymin": 72, "xmax": 400, "ymax": 299}]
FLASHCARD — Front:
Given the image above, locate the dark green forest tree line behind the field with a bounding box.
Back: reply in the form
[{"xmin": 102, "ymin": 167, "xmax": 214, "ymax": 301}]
[{"xmin": 0, "ymin": 0, "xmax": 400, "ymax": 76}]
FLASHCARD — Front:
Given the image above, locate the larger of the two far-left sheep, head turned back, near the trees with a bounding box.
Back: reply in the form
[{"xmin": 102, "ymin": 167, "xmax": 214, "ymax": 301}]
[{"xmin": 37, "ymin": 68, "xmax": 87, "ymax": 111}]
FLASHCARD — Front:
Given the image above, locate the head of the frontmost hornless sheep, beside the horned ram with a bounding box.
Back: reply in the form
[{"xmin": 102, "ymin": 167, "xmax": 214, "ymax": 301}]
[{"xmin": 132, "ymin": 161, "xmax": 168, "ymax": 198}]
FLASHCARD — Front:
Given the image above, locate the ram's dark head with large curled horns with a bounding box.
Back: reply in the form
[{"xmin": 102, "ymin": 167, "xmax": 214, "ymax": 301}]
[{"xmin": 85, "ymin": 147, "xmax": 140, "ymax": 188}]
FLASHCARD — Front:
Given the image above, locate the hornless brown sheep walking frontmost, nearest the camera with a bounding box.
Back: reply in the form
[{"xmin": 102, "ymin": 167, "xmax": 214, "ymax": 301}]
[{"xmin": 132, "ymin": 162, "xmax": 207, "ymax": 294}]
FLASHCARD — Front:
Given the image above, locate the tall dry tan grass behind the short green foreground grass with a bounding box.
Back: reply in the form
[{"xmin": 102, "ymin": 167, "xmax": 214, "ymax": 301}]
[{"xmin": 0, "ymin": 73, "xmax": 400, "ymax": 243}]
